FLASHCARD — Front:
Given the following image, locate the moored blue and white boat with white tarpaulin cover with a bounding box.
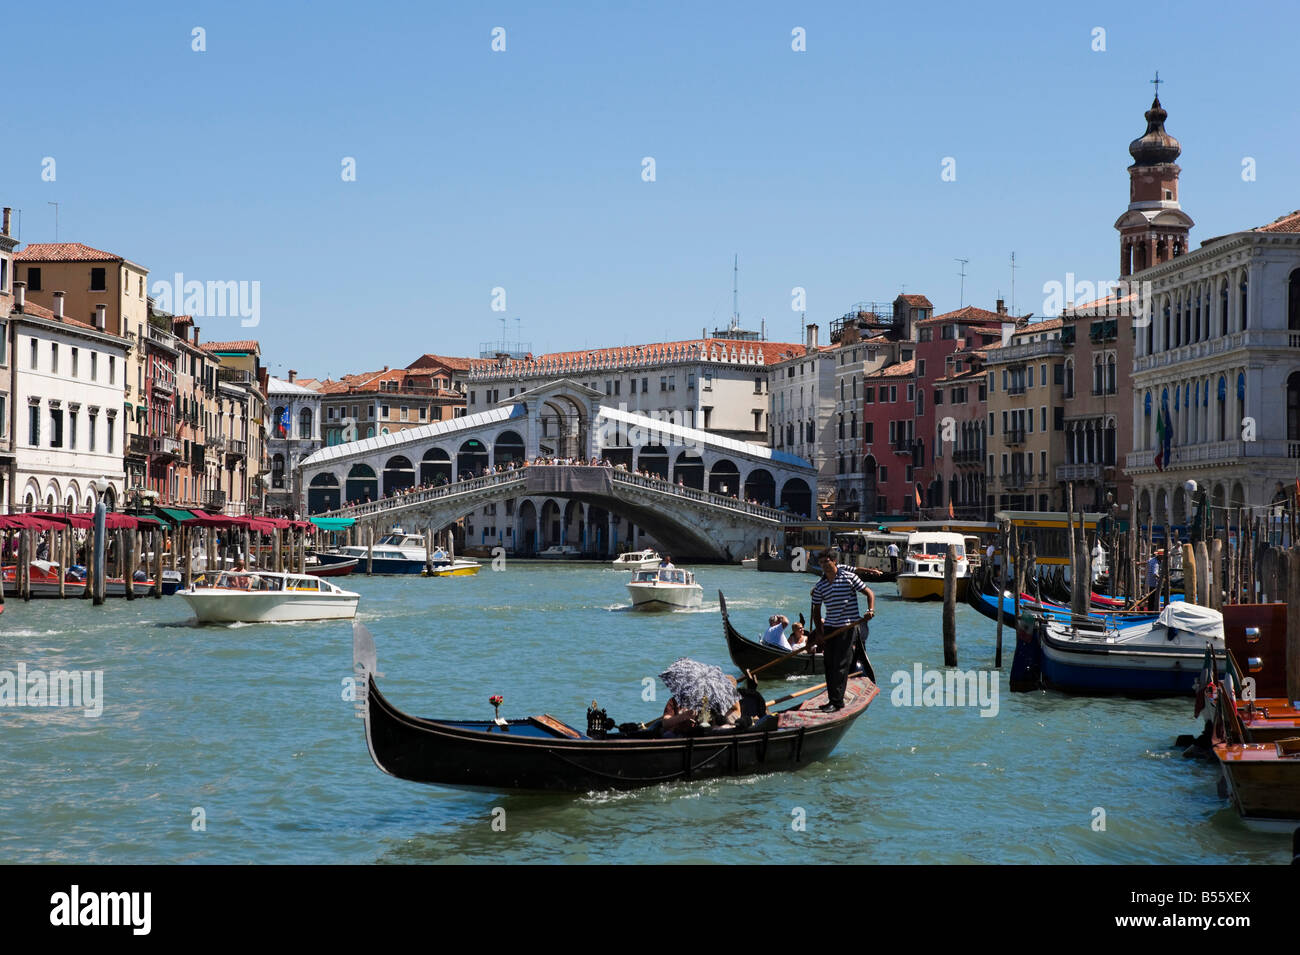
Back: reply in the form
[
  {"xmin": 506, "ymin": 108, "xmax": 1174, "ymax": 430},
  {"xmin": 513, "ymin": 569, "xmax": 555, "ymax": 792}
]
[{"xmin": 1040, "ymin": 600, "xmax": 1225, "ymax": 695}]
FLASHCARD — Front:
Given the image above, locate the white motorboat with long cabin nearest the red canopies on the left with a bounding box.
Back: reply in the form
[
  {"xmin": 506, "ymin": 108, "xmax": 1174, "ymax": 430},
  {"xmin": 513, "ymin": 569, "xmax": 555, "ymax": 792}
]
[{"xmin": 177, "ymin": 570, "xmax": 360, "ymax": 624}]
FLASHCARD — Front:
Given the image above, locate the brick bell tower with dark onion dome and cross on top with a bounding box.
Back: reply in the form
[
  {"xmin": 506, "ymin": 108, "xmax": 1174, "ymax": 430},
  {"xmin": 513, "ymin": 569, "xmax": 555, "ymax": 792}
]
[{"xmin": 1115, "ymin": 73, "xmax": 1196, "ymax": 278}]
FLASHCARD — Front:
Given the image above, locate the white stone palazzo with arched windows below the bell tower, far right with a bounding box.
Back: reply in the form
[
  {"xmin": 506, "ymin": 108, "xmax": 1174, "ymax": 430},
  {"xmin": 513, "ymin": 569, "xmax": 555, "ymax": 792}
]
[{"xmin": 1127, "ymin": 212, "xmax": 1300, "ymax": 525}]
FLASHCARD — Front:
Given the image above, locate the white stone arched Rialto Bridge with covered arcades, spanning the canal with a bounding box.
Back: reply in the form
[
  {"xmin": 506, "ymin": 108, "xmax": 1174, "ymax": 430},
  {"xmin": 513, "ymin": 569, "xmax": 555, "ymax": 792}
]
[{"xmin": 299, "ymin": 379, "xmax": 816, "ymax": 560}]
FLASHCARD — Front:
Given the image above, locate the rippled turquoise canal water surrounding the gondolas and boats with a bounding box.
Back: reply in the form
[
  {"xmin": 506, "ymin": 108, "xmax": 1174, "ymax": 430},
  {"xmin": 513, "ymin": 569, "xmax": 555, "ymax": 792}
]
[{"xmin": 0, "ymin": 561, "xmax": 1290, "ymax": 864}]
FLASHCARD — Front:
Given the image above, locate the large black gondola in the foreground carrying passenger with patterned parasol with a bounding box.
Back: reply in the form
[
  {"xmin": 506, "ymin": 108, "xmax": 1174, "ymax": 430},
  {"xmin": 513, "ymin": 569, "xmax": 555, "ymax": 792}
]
[{"xmin": 352, "ymin": 622, "xmax": 880, "ymax": 793}]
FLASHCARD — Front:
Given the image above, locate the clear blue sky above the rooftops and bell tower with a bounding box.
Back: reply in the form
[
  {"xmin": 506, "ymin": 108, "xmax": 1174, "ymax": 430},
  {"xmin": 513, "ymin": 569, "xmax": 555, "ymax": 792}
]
[{"xmin": 0, "ymin": 0, "xmax": 1300, "ymax": 377}]
